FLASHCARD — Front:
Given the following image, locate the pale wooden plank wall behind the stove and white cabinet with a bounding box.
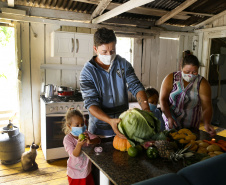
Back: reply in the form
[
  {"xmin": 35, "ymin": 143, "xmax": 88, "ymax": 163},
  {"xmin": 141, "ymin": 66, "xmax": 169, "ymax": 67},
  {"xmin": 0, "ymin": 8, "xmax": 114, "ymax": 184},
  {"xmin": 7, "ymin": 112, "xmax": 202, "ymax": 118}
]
[{"xmin": 20, "ymin": 23, "xmax": 94, "ymax": 145}]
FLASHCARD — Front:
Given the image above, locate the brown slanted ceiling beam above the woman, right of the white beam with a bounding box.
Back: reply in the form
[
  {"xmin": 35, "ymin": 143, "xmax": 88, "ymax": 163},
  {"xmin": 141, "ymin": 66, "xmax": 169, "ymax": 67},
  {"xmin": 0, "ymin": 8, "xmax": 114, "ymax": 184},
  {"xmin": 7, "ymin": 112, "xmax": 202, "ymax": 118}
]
[{"xmin": 155, "ymin": 0, "xmax": 197, "ymax": 25}]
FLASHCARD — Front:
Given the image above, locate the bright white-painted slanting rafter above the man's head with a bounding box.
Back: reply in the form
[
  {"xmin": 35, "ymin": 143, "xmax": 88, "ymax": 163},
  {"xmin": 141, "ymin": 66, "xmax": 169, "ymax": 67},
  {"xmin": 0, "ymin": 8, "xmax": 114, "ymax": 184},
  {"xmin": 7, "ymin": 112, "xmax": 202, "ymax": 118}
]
[{"xmin": 92, "ymin": 0, "xmax": 154, "ymax": 23}]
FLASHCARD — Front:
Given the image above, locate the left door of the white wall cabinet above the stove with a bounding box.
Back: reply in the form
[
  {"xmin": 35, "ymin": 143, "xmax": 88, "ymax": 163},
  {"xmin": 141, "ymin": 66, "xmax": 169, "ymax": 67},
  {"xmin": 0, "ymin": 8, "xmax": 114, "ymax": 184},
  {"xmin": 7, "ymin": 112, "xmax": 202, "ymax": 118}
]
[{"xmin": 51, "ymin": 32, "xmax": 74, "ymax": 57}]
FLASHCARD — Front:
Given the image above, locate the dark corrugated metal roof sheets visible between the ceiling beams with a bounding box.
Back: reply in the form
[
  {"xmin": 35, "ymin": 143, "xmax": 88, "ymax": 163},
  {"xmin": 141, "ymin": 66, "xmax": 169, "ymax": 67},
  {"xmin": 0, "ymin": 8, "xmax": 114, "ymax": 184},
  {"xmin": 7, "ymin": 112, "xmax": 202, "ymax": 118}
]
[{"xmin": 0, "ymin": 0, "xmax": 226, "ymax": 26}]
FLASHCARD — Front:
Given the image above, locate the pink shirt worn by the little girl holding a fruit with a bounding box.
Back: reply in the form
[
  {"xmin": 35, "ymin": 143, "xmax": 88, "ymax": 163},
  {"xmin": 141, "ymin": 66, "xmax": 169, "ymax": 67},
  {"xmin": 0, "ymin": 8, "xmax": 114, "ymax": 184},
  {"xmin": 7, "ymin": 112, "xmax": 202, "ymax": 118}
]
[{"xmin": 63, "ymin": 132, "xmax": 97, "ymax": 179}]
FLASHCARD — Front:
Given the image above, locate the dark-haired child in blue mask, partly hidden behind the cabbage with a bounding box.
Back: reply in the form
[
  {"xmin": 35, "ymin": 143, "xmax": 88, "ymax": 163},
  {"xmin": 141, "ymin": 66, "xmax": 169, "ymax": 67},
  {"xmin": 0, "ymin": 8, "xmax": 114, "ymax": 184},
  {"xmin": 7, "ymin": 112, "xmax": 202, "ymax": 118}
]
[{"xmin": 145, "ymin": 88, "xmax": 165, "ymax": 131}]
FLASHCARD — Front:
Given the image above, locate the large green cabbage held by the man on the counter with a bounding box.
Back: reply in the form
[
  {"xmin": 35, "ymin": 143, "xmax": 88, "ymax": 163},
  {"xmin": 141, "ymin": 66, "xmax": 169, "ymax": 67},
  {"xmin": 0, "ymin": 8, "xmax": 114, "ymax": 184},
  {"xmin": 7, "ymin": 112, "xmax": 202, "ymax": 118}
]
[{"xmin": 118, "ymin": 108, "xmax": 160, "ymax": 146}]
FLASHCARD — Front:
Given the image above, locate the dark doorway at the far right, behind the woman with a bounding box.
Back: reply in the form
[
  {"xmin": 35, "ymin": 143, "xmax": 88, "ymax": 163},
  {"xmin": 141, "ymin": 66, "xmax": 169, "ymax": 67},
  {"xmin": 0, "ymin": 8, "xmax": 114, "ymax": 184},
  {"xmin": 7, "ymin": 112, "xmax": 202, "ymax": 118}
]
[{"xmin": 208, "ymin": 37, "xmax": 226, "ymax": 128}]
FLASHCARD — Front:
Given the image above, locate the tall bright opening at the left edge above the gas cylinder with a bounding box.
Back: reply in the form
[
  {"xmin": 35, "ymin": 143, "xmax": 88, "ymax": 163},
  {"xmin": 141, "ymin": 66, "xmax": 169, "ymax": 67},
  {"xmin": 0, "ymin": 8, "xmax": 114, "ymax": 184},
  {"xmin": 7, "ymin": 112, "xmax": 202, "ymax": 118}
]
[{"xmin": 0, "ymin": 26, "xmax": 19, "ymax": 127}]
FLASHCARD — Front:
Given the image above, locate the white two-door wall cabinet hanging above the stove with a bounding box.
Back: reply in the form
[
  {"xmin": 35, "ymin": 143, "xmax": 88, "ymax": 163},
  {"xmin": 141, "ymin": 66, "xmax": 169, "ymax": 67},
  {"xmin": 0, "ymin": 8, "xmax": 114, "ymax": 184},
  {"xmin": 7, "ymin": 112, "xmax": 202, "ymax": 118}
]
[{"xmin": 51, "ymin": 31, "xmax": 93, "ymax": 58}]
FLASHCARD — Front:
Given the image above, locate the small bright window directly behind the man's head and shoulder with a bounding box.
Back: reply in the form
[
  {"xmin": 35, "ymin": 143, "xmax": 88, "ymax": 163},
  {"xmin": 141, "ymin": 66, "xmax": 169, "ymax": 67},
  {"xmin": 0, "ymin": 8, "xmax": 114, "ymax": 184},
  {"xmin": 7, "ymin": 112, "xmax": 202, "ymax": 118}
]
[{"xmin": 116, "ymin": 37, "xmax": 133, "ymax": 64}]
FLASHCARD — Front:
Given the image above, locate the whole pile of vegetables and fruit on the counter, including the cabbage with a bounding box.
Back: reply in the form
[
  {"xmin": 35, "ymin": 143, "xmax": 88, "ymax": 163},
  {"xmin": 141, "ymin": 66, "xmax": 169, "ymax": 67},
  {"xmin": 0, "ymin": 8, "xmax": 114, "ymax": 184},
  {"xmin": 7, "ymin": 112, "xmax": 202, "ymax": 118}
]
[{"xmin": 113, "ymin": 108, "xmax": 226, "ymax": 160}]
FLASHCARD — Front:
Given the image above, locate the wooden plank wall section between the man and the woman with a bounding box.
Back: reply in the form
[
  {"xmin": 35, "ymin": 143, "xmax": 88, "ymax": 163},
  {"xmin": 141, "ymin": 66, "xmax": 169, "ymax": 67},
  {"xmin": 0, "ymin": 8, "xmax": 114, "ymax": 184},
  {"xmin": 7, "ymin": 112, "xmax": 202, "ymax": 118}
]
[{"xmin": 141, "ymin": 33, "xmax": 193, "ymax": 91}]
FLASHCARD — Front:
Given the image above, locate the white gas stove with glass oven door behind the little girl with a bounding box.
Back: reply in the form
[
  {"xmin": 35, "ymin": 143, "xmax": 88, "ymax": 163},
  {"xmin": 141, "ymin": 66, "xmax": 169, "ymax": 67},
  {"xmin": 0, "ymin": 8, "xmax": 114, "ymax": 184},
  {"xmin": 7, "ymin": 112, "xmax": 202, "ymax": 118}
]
[{"xmin": 40, "ymin": 93, "xmax": 88, "ymax": 161}]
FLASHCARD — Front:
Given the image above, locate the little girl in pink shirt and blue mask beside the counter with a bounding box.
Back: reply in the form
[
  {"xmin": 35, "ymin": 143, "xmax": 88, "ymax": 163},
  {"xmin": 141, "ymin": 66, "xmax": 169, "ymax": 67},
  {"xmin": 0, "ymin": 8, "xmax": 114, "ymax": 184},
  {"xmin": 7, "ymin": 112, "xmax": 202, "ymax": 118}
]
[{"xmin": 63, "ymin": 109, "xmax": 100, "ymax": 185}]
